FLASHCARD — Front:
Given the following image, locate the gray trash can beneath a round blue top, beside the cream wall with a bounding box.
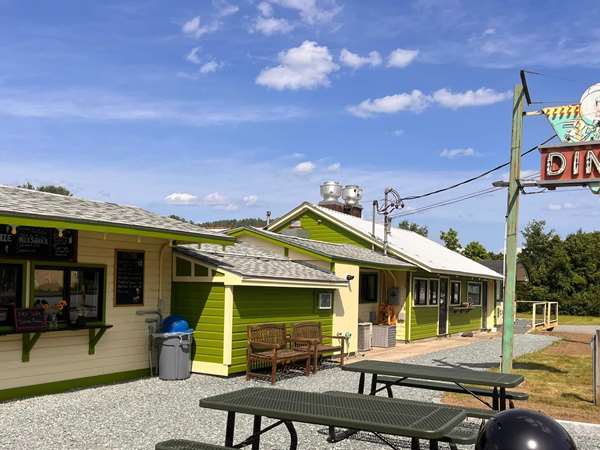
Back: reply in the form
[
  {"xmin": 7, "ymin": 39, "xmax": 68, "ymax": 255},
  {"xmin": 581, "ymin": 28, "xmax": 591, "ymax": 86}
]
[{"xmin": 152, "ymin": 330, "xmax": 194, "ymax": 380}]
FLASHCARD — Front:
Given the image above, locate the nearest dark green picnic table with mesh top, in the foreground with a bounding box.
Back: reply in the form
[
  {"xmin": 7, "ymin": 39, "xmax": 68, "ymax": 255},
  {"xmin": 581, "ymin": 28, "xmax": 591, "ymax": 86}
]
[{"xmin": 200, "ymin": 387, "xmax": 470, "ymax": 450}]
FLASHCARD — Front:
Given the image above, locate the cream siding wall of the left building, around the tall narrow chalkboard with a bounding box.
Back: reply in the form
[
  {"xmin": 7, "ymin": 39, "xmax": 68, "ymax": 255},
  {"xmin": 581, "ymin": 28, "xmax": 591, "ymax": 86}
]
[{"xmin": 0, "ymin": 232, "xmax": 171, "ymax": 390}]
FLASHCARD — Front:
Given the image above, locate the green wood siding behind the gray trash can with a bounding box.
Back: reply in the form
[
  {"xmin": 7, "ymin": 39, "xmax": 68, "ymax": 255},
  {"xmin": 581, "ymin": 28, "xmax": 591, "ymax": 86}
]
[{"xmin": 171, "ymin": 283, "xmax": 225, "ymax": 363}]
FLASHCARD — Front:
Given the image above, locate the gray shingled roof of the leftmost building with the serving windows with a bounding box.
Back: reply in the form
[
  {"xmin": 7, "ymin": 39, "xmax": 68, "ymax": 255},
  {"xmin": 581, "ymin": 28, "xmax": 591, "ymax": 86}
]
[{"xmin": 0, "ymin": 185, "xmax": 232, "ymax": 241}]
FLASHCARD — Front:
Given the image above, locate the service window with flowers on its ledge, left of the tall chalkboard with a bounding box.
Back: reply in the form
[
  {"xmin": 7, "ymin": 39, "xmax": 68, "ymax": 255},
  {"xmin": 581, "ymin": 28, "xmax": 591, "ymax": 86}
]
[{"xmin": 33, "ymin": 267, "xmax": 104, "ymax": 322}]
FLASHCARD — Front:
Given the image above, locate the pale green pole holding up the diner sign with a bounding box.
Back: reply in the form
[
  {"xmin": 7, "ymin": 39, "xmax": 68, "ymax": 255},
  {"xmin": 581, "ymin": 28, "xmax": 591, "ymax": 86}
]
[{"xmin": 501, "ymin": 84, "xmax": 525, "ymax": 373}]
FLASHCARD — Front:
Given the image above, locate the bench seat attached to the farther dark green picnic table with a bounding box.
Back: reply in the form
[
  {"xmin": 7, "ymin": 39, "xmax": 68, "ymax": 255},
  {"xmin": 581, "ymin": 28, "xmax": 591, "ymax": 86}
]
[{"xmin": 377, "ymin": 375, "xmax": 529, "ymax": 410}]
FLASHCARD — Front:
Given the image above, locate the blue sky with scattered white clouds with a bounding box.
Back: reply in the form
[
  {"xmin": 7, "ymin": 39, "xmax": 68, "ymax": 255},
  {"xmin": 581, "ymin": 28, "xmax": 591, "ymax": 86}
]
[{"xmin": 0, "ymin": 0, "xmax": 600, "ymax": 250}]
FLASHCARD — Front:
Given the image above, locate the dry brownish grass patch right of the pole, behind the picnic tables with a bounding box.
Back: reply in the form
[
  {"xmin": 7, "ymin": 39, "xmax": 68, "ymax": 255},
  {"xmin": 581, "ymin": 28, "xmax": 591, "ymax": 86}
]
[{"xmin": 444, "ymin": 333, "xmax": 600, "ymax": 423}]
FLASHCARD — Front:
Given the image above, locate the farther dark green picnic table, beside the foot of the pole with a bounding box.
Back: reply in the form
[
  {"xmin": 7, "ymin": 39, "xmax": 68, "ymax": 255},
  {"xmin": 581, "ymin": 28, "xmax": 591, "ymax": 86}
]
[{"xmin": 342, "ymin": 360, "xmax": 524, "ymax": 411}]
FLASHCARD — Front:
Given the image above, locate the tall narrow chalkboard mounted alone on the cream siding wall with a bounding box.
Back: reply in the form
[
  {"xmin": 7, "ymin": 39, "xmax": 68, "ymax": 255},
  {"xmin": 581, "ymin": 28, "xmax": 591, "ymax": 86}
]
[{"xmin": 115, "ymin": 250, "xmax": 144, "ymax": 305}]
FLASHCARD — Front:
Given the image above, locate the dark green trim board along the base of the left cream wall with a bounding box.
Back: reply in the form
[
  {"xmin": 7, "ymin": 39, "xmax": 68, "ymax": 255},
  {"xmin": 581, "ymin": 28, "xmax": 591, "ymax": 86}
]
[{"xmin": 0, "ymin": 369, "xmax": 150, "ymax": 402}]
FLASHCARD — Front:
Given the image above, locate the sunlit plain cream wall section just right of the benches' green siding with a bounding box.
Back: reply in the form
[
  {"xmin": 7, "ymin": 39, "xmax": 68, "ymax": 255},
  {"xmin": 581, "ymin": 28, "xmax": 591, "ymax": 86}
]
[{"xmin": 332, "ymin": 263, "xmax": 359, "ymax": 353}]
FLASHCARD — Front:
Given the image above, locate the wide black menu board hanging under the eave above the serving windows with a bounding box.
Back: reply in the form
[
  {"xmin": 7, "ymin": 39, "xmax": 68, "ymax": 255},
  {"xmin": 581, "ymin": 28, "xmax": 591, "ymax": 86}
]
[{"xmin": 0, "ymin": 225, "xmax": 77, "ymax": 261}]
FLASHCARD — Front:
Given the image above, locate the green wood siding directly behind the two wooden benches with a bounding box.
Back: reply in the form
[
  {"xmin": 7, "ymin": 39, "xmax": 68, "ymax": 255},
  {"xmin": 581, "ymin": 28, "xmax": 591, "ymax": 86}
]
[{"xmin": 229, "ymin": 286, "xmax": 333, "ymax": 374}]
